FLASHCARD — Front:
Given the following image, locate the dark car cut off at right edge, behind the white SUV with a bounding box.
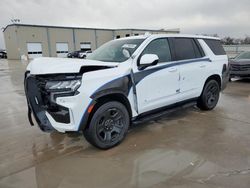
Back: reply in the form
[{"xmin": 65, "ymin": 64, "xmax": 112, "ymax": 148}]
[{"xmin": 229, "ymin": 52, "xmax": 250, "ymax": 79}]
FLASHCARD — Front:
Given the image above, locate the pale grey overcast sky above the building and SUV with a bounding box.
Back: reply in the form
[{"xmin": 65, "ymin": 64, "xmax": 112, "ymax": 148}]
[{"xmin": 0, "ymin": 0, "xmax": 250, "ymax": 48}]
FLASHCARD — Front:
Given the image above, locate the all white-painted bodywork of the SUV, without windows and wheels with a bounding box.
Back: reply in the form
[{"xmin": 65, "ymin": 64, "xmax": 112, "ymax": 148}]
[{"xmin": 27, "ymin": 35, "xmax": 228, "ymax": 132}]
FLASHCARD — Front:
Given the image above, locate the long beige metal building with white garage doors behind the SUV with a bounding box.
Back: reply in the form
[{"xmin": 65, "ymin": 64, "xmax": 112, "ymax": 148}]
[{"xmin": 3, "ymin": 24, "xmax": 179, "ymax": 59}]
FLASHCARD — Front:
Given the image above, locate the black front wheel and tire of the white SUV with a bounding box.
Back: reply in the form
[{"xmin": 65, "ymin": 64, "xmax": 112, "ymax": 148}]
[{"xmin": 83, "ymin": 101, "xmax": 130, "ymax": 149}]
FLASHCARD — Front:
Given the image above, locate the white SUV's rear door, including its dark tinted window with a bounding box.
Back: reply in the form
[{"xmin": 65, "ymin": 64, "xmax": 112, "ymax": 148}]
[{"xmin": 172, "ymin": 38, "xmax": 210, "ymax": 101}]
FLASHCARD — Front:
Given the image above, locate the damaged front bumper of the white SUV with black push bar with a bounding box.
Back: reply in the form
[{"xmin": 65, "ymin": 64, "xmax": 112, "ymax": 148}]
[{"xmin": 24, "ymin": 72, "xmax": 90, "ymax": 132}]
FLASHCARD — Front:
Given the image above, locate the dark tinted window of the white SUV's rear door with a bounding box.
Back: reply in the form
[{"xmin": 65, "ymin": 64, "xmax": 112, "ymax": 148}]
[{"xmin": 173, "ymin": 38, "xmax": 204, "ymax": 61}]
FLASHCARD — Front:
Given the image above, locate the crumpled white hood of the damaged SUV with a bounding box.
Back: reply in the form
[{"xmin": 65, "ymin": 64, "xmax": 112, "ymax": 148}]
[{"xmin": 27, "ymin": 57, "xmax": 119, "ymax": 75}]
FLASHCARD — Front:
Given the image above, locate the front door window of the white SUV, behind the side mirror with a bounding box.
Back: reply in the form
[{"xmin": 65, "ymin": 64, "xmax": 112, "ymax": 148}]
[{"xmin": 141, "ymin": 38, "xmax": 171, "ymax": 63}]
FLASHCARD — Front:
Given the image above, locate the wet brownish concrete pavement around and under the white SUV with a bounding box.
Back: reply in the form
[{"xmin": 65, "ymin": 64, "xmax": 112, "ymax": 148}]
[{"xmin": 0, "ymin": 60, "xmax": 250, "ymax": 188}]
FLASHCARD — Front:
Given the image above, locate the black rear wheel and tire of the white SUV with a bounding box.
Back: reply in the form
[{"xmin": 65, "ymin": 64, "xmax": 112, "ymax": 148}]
[{"xmin": 197, "ymin": 80, "xmax": 220, "ymax": 111}]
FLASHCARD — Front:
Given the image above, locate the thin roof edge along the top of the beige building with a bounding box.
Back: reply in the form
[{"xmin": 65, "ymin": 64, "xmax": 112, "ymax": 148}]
[{"xmin": 3, "ymin": 24, "xmax": 180, "ymax": 32}]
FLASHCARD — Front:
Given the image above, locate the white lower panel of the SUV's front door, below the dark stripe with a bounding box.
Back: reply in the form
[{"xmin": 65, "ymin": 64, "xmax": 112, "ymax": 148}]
[{"xmin": 134, "ymin": 63, "xmax": 179, "ymax": 113}]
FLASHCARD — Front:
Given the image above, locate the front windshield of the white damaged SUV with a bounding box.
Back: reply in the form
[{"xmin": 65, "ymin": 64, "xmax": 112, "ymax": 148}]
[{"xmin": 87, "ymin": 39, "xmax": 144, "ymax": 62}]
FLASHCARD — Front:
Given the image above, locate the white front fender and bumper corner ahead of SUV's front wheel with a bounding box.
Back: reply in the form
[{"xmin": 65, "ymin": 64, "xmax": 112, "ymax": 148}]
[{"xmin": 51, "ymin": 63, "xmax": 129, "ymax": 132}]
